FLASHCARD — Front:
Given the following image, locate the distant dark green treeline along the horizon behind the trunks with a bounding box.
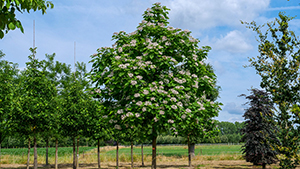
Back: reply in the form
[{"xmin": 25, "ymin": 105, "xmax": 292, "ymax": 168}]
[{"xmin": 1, "ymin": 121, "xmax": 244, "ymax": 148}]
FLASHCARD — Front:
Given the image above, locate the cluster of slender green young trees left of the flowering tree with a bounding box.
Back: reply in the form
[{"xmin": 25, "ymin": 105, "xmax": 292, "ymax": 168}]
[{"xmin": 0, "ymin": 49, "xmax": 99, "ymax": 168}]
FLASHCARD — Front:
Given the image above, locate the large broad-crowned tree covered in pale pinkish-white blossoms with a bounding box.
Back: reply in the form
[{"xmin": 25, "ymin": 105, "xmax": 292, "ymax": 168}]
[{"xmin": 90, "ymin": 3, "xmax": 219, "ymax": 168}]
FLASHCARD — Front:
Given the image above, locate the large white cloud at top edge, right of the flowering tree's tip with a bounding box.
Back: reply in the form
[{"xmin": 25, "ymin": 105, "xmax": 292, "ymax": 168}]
[{"xmin": 167, "ymin": 0, "xmax": 270, "ymax": 29}]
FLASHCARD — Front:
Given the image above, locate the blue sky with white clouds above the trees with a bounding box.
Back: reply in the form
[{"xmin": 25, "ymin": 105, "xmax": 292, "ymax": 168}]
[{"xmin": 0, "ymin": 0, "xmax": 300, "ymax": 122}]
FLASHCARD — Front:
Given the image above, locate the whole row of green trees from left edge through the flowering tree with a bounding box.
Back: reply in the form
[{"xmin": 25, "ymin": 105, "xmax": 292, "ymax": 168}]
[{"xmin": 0, "ymin": 3, "xmax": 221, "ymax": 168}]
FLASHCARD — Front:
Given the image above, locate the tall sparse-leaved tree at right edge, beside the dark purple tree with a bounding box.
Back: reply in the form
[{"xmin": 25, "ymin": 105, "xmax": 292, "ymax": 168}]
[{"xmin": 242, "ymin": 13, "xmax": 300, "ymax": 168}]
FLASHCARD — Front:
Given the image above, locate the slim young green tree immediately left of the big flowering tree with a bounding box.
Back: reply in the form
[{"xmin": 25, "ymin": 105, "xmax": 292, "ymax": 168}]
[{"xmin": 60, "ymin": 62, "xmax": 92, "ymax": 169}]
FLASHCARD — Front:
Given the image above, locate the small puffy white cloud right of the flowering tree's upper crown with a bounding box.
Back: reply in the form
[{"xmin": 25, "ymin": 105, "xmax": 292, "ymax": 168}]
[{"xmin": 213, "ymin": 30, "xmax": 253, "ymax": 53}]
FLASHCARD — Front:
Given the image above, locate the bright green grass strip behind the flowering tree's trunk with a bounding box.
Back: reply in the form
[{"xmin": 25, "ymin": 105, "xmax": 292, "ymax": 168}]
[{"xmin": 103, "ymin": 145, "xmax": 241, "ymax": 157}]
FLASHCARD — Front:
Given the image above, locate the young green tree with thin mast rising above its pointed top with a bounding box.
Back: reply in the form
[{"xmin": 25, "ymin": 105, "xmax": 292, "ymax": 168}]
[{"xmin": 13, "ymin": 48, "xmax": 57, "ymax": 169}]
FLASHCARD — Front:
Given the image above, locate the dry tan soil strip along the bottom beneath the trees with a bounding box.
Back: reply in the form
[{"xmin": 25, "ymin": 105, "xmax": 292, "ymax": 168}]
[{"xmin": 1, "ymin": 160, "xmax": 290, "ymax": 169}]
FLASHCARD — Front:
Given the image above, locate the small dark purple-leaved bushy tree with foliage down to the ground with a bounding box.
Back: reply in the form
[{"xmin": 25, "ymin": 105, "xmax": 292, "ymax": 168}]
[{"xmin": 241, "ymin": 89, "xmax": 279, "ymax": 168}]
